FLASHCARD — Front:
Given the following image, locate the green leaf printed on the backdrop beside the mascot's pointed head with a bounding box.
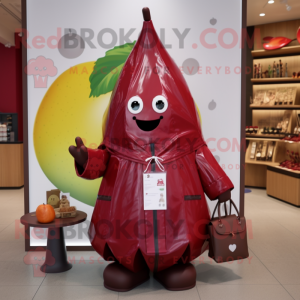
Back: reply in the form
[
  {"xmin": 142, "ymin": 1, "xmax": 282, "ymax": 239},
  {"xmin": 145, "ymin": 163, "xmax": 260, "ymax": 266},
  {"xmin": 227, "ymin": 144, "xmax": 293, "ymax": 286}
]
[{"xmin": 90, "ymin": 41, "xmax": 135, "ymax": 97}]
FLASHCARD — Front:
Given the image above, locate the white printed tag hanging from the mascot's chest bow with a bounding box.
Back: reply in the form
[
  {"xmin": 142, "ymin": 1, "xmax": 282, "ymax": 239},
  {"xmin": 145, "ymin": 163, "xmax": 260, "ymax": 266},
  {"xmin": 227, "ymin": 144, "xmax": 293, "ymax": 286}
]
[{"xmin": 143, "ymin": 172, "xmax": 167, "ymax": 210}]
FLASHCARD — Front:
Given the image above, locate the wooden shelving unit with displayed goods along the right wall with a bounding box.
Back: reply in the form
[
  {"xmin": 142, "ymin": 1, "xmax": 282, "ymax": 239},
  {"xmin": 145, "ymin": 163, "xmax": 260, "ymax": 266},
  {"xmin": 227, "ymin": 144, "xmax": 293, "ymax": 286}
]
[{"xmin": 250, "ymin": 20, "xmax": 300, "ymax": 199}]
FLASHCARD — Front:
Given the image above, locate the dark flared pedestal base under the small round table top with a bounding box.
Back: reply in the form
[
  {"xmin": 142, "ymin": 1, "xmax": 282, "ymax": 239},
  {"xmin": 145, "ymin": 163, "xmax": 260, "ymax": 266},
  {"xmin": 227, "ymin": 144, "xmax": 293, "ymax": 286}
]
[{"xmin": 41, "ymin": 227, "xmax": 72, "ymax": 273}]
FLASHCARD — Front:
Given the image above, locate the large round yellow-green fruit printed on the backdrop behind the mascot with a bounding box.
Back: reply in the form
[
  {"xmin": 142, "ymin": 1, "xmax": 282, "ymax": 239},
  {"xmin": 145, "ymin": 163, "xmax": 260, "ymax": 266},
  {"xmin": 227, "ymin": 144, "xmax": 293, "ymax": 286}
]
[{"xmin": 33, "ymin": 62, "xmax": 111, "ymax": 206}]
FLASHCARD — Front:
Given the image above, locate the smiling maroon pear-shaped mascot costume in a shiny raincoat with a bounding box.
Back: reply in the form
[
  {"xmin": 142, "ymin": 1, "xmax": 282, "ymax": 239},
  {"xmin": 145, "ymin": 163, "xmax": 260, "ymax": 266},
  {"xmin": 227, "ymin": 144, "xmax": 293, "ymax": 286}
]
[{"xmin": 69, "ymin": 8, "xmax": 233, "ymax": 291}]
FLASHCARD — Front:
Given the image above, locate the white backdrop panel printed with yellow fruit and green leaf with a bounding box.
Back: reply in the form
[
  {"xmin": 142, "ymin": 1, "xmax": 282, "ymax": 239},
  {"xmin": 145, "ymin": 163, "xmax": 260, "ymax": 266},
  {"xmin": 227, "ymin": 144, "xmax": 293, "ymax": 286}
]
[{"xmin": 25, "ymin": 0, "xmax": 242, "ymax": 246}]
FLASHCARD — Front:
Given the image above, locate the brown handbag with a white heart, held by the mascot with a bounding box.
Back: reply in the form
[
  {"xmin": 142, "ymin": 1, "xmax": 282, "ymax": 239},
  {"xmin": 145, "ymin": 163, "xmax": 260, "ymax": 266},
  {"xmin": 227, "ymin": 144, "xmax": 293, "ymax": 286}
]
[{"xmin": 207, "ymin": 199, "xmax": 249, "ymax": 263}]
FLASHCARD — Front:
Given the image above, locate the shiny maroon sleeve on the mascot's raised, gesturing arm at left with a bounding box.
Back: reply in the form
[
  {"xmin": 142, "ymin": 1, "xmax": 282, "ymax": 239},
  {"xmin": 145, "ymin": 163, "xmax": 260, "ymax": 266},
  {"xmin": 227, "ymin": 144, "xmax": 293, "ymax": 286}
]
[{"xmin": 75, "ymin": 146, "xmax": 110, "ymax": 179}]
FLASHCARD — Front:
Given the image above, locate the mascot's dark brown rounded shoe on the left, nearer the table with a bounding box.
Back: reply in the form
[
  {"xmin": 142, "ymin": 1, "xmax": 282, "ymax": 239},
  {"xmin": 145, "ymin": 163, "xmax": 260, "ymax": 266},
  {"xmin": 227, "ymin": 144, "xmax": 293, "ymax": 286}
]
[{"xmin": 103, "ymin": 262, "xmax": 150, "ymax": 292}]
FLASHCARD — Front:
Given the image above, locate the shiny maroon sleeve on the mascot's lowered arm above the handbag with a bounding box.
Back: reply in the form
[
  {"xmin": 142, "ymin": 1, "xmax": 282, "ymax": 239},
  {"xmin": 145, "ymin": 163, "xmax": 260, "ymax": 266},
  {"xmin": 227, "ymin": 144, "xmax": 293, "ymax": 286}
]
[{"xmin": 196, "ymin": 144, "xmax": 234, "ymax": 200}]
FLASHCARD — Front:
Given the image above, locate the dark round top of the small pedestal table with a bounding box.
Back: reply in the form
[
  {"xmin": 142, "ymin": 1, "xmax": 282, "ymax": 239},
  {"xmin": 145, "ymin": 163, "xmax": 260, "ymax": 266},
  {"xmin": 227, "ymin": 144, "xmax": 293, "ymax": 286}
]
[{"xmin": 20, "ymin": 210, "xmax": 87, "ymax": 228}]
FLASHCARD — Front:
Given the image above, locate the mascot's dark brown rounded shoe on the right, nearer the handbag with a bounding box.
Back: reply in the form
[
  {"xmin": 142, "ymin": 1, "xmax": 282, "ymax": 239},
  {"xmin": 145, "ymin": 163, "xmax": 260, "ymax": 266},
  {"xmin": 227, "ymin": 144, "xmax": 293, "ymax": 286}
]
[{"xmin": 153, "ymin": 263, "xmax": 197, "ymax": 291}]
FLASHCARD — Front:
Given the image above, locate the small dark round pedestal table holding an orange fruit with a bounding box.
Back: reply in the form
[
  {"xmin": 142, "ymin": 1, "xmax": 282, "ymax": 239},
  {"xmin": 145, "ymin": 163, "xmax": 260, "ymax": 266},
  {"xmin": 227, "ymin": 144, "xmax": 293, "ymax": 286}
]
[{"xmin": 20, "ymin": 210, "xmax": 87, "ymax": 273}]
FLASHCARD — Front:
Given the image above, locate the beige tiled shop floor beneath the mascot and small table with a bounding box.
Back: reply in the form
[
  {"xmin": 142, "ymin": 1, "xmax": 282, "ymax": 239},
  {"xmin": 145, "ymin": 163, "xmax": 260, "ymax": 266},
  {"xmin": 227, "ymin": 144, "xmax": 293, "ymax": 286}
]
[{"xmin": 0, "ymin": 189, "xmax": 300, "ymax": 300}]
